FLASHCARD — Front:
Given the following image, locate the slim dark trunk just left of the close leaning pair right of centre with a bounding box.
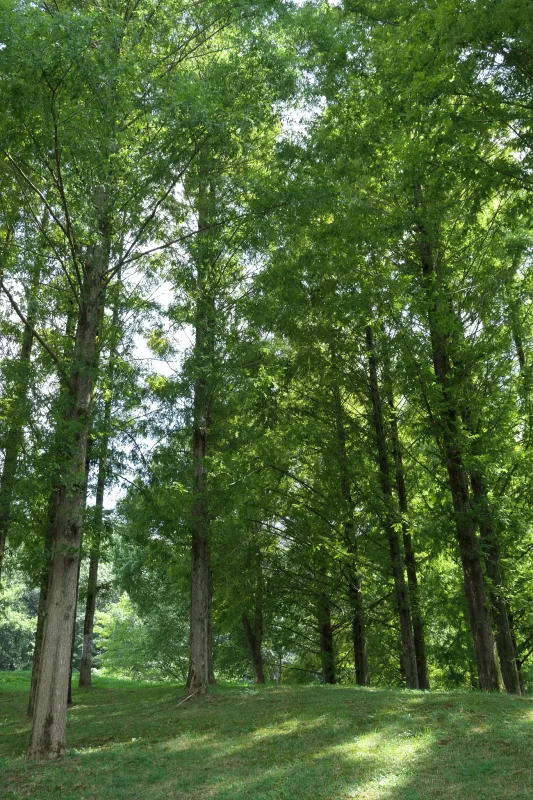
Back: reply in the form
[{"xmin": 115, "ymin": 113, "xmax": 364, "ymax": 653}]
[{"xmin": 332, "ymin": 378, "xmax": 370, "ymax": 686}]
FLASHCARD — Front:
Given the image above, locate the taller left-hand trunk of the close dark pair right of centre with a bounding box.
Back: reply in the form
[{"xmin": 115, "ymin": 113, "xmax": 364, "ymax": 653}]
[{"xmin": 366, "ymin": 326, "xmax": 418, "ymax": 689}]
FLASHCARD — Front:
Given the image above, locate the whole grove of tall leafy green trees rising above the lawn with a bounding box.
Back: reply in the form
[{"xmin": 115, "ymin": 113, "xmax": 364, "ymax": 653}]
[{"xmin": 0, "ymin": 0, "xmax": 533, "ymax": 759}]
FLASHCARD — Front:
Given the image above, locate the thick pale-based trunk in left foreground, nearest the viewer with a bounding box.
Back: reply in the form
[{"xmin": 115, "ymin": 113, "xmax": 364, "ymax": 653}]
[{"xmin": 28, "ymin": 190, "xmax": 110, "ymax": 759}]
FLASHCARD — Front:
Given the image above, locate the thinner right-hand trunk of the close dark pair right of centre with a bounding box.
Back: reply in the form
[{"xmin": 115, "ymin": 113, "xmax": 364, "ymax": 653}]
[{"xmin": 388, "ymin": 376, "xmax": 430, "ymax": 690}]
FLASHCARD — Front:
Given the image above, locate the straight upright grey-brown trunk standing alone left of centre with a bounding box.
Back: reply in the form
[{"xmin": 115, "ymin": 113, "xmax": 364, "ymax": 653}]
[{"xmin": 187, "ymin": 178, "xmax": 214, "ymax": 695}]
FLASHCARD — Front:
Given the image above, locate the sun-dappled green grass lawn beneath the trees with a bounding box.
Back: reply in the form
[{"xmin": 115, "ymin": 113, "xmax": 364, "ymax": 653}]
[{"xmin": 0, "ymin": 672, "xmax": 533, "ymax": 800}]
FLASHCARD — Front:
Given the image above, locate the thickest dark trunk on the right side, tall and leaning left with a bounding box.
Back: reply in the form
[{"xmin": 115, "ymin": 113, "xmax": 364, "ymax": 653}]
[{"xmin": 418, "ymin": 222, "xmax": 499, "ymax": 691}]
